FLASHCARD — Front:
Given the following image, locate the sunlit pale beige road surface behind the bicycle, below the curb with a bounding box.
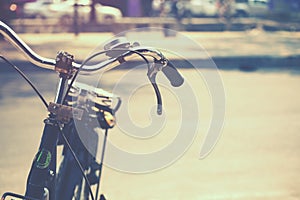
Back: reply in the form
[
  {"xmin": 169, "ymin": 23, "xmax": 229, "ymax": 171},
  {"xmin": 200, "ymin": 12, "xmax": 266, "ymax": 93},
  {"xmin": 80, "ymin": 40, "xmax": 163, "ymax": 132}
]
[{"xmin": 0, "ymin": 69, "xmax": 300, "ymax": 200}]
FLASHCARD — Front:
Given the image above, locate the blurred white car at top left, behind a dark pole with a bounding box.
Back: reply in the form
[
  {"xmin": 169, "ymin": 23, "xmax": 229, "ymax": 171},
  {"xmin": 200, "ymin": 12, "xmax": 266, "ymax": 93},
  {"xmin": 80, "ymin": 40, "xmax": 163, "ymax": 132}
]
[{"xmin": 23, "ymin": 0, "xmax": 122, "ymax": 25}]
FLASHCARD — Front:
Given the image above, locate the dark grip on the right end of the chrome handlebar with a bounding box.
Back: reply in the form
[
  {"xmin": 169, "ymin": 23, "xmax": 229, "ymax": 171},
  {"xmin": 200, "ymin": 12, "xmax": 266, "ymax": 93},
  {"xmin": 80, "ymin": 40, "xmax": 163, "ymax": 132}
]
[{"xmin": 162, "ymin": 62, "xmax": 184, "ymax": 87}]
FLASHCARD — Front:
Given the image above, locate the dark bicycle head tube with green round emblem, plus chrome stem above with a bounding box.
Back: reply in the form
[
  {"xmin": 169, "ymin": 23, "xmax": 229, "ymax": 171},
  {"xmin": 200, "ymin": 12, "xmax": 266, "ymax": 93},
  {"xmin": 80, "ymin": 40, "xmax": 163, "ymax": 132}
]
[{"xmin": 25, "ymin": 76, "xmax": 68, "ymax": 200}]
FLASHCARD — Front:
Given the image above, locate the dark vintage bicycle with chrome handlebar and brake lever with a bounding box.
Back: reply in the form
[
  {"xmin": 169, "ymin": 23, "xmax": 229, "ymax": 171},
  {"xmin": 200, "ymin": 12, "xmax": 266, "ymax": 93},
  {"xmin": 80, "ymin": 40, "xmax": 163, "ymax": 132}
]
[{"xmin": 0, "ymin": 21, "xmax": 184, "ymax": 200}]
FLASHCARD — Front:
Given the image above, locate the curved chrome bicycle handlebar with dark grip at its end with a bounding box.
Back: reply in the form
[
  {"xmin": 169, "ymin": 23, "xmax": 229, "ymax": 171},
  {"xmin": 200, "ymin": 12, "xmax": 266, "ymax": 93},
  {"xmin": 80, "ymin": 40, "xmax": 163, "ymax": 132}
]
[{"xmin": 0, "ymin": 21, "xmax": 183, "ymax": 87}]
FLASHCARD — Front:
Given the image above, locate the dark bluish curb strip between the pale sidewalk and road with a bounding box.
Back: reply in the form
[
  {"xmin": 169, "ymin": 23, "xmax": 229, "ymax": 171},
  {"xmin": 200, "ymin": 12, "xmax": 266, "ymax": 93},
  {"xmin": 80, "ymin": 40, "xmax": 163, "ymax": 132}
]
[{"xmin": 0, "ymin": 55, "xmax": 300, "ymax": 73}]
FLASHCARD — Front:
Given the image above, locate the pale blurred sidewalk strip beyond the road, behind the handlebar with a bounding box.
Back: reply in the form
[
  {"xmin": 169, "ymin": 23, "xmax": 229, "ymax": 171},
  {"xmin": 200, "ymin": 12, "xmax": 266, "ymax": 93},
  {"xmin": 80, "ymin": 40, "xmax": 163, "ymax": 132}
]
[{"xmin": 0, "ymin": 29, "xmax": 300, "ymax": 69}]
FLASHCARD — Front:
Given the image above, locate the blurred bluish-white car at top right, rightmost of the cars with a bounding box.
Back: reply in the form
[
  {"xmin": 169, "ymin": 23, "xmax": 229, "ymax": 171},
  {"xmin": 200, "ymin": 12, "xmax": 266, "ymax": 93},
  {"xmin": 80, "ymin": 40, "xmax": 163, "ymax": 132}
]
[{"xmin": 234, "ymin": 0, "xmax": 269, "ymax": 17}]
